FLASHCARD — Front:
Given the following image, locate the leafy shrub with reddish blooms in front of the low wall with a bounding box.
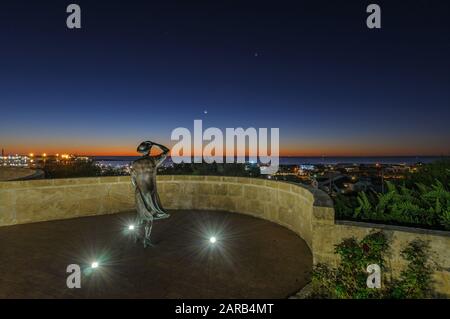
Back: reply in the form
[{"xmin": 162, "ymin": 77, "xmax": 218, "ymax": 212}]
[{"xmin": 312, "ymin": 232, "xmax": 432, "ymax": 299}]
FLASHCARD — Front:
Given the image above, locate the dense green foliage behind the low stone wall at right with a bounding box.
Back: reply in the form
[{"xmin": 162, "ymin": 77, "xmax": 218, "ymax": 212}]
[{"xmin": 335, "ymin": 159, "xmax": 450, "ymax": 230}]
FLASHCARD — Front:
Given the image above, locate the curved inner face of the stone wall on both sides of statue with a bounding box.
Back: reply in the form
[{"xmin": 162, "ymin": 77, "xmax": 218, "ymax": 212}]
[{"xmin": 0, "ymin": 175, "xmax": 332, "ymax": 248}]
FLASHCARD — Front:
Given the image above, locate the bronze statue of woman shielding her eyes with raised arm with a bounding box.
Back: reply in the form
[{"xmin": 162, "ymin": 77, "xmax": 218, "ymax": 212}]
[{"xmin": 131, "ymin": 141, "xmax": 170, "ymax": 247}]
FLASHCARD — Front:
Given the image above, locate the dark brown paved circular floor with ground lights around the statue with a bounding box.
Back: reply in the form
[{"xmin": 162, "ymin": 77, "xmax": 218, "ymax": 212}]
[{"xmin": 0, "ymin": 211, "xmax": 312, "ymax": 298}]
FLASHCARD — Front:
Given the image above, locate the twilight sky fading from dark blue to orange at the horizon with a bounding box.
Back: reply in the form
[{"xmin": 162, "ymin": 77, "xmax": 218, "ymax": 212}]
[{"xmin": 0, "ymin": 0, "xmax": 450, "ymax": 156}]
